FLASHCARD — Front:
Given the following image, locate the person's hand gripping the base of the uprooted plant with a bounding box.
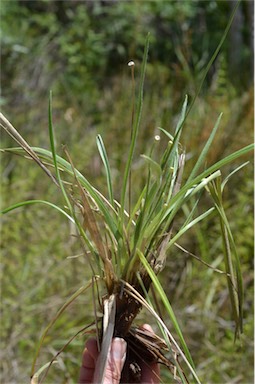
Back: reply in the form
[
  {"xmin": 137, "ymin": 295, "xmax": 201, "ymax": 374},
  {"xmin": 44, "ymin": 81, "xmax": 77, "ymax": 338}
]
[{"xmin": 79, "ymin": 324, "xmax": 160, "ymax": 384}]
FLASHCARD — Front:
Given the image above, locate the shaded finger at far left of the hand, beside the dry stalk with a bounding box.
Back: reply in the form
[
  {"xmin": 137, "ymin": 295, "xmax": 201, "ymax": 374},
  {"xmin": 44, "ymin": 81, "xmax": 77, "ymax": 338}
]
[{"xmin": 79, "ymin": 338, "xmax": 98, "ymax": 384}]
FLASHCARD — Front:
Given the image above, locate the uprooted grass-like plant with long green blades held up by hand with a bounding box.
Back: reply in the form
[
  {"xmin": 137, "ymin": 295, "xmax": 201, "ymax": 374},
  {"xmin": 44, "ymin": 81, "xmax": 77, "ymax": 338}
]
[{"xmin": 0, "ymin": 7, "xmax": 253, "ymax": 384}]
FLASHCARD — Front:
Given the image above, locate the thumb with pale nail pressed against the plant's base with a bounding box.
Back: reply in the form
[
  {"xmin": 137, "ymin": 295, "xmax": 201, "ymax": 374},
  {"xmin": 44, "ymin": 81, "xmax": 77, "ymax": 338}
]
[{"xmin": 104, "ymin": 337, "xmax": 127, "ymax": 384}]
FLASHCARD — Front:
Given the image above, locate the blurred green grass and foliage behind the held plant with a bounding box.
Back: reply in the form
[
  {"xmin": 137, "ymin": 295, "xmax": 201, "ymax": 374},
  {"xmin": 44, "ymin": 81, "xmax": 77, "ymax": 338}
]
[{"xmin": 0, "ymin": 0, "xmax": 253, "ymax": 384}]
